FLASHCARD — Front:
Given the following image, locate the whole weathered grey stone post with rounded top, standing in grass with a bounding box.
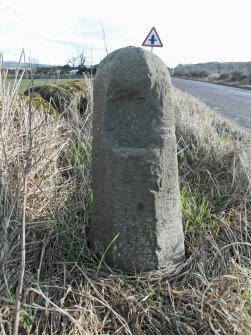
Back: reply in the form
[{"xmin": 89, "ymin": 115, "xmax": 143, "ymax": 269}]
[{"xmin": 91, "ymin": 47, "xmax": 184, "ymax": 272}]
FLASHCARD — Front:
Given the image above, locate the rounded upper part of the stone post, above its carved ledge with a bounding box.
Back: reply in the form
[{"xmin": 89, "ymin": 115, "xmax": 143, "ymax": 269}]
[{"xmin": 94, "ymin": 47, "xmax": 174, "ymax": 148}]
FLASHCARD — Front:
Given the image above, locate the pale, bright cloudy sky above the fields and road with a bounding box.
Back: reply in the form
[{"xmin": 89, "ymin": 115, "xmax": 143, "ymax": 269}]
[{"xmin": 0, "ymin": 0, "xmax": 251, "ymax": 67}]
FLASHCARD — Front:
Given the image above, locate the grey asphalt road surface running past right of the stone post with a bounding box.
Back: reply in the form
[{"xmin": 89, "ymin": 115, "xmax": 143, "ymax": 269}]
[{"xmin": 172, "ymin": 78, "xmax": 251, "ymax": 129}]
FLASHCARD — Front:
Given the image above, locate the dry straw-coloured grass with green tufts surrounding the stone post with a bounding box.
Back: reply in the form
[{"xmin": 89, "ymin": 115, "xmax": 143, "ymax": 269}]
[{"xmin": 0, "ymin": 69, "xmax": 251, "ymax": 335}]
